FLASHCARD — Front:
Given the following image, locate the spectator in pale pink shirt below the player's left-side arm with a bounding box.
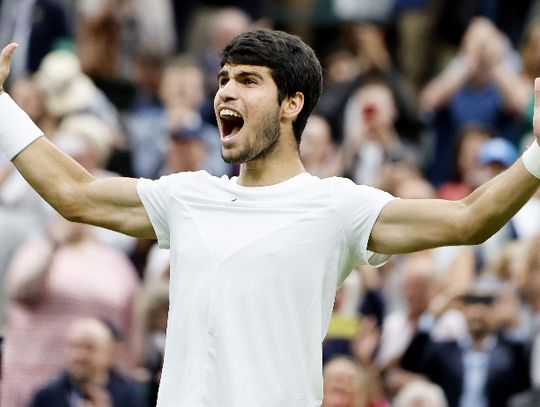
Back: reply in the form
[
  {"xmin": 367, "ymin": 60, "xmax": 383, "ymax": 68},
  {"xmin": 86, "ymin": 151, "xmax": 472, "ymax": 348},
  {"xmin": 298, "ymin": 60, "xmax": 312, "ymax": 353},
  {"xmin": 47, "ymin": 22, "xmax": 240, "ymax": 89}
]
[{"xmin": 0, "ymin": 217, "xmax": 138, "ymax": 407}]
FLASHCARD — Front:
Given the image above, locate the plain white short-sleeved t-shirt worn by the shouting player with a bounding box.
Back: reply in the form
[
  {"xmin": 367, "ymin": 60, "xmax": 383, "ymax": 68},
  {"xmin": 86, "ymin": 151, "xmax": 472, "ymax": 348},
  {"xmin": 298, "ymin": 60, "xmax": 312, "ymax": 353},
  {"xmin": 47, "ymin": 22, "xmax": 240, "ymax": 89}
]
[{"xmin": 137, "ymin": 171, "xmax": 393, "ymax": 407}]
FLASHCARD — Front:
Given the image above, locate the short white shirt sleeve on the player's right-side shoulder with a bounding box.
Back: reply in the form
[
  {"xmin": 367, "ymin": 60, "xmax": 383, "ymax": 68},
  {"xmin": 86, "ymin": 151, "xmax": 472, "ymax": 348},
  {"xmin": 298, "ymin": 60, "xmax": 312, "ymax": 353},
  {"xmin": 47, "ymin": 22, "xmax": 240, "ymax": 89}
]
[{"xmin": 333, "ymin": 179, "xmax": 396, "ymax": 267}]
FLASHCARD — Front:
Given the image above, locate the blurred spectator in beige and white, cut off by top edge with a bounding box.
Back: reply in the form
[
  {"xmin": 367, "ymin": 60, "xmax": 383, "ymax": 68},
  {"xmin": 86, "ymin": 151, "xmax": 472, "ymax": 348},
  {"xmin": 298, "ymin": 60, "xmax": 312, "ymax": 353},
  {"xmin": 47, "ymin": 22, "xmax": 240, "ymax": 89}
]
[{"xmin": 76, "ymin": 0, "xmax": 176, "ymax": 84}]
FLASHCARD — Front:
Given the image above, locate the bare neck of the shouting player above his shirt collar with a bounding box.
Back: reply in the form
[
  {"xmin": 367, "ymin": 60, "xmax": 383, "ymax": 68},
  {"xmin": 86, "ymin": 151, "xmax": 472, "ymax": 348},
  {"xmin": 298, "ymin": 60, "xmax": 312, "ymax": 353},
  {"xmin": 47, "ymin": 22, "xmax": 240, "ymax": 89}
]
[{"xmin": 238, "ymin": 131, "xmax": 306, "ymax": 187}]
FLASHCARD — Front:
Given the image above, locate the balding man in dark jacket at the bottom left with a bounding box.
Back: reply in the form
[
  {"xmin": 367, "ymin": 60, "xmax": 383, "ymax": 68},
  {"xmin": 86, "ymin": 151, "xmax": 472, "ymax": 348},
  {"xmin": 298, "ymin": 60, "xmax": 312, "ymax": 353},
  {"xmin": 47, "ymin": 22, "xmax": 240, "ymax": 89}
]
[{"xmin": 30, "ymin": 318, "xmax": 145, "ymax": 407}]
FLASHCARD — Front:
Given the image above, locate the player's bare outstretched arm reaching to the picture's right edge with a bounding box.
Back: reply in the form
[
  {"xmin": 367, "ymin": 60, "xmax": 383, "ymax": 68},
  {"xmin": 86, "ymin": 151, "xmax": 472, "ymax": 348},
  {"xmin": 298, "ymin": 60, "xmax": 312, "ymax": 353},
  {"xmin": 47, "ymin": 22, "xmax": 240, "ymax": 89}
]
[{"xmin": 368, "ymin": 79, "xmax": 540, "ymax": 254}]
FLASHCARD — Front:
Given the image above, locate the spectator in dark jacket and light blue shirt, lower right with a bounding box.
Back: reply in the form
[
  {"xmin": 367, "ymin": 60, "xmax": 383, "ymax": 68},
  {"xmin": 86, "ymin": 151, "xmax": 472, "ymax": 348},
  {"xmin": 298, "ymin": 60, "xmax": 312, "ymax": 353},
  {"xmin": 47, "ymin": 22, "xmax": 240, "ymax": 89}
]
[{"xmin": 401, "ymin": 277, "xmax": 530, "ymax": 407}]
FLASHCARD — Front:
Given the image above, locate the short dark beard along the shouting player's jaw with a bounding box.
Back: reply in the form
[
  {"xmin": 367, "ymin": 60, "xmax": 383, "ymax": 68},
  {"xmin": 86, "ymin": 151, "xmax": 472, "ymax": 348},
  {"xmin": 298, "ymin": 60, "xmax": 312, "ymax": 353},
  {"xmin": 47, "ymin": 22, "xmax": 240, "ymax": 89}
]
[{"xmin": 221, "ymin": 108, "xmax": 280, "ymax": 164}]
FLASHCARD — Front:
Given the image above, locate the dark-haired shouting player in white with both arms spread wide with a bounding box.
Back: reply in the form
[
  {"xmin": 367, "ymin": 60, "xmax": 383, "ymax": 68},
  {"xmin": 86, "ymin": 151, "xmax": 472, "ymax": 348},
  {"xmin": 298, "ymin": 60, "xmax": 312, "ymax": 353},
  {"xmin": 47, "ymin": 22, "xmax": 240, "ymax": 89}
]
[{"xmin": 0, "ymin": 30, "xmax": 540, "ymax": 407}]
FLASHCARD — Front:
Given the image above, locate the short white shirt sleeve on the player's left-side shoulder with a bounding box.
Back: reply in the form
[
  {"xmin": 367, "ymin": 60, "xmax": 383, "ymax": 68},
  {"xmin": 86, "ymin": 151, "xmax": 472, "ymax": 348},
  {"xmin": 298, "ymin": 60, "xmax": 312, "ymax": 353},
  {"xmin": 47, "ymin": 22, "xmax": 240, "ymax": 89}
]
[{"xmin": 137, "ymin": 173, "xmax": 186, "ymax": 249}]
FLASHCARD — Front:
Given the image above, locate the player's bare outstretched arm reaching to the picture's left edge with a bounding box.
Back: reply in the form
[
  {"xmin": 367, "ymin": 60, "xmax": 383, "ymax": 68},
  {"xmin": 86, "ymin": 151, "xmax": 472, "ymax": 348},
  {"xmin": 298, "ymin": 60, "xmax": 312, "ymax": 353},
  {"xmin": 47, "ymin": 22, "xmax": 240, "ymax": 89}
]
[{"xmin": 0, "ymin": 44, "xmax": 155, "ymax": 238}]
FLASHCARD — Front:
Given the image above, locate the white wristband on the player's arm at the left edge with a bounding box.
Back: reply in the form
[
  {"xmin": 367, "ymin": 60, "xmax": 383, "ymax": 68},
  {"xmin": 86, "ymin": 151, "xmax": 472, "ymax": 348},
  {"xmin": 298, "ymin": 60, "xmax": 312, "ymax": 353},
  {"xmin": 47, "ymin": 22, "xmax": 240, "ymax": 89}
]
[{"xmin": 0, "ymin": 92, "xmax": 43, "ymax": 160}]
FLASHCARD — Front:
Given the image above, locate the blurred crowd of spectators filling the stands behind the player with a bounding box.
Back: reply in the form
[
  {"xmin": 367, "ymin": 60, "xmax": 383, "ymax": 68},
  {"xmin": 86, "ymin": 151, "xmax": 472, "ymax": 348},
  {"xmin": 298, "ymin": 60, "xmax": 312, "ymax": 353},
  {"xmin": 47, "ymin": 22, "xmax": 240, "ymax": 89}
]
[{"xmin": 0, "ymin": 0, "xmax": 540, "ymax": 407}]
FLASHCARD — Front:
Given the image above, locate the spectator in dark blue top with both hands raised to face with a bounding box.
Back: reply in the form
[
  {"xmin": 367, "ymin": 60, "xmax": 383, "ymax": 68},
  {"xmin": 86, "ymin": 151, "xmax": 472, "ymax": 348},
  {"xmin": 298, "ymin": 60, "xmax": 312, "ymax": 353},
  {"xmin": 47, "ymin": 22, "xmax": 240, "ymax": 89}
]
[{"xmin": 420, "ymin": 18, "xmax": 523, "ymax": 186}]
